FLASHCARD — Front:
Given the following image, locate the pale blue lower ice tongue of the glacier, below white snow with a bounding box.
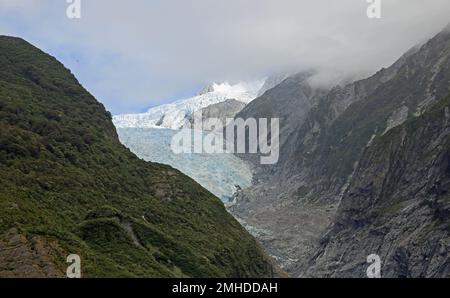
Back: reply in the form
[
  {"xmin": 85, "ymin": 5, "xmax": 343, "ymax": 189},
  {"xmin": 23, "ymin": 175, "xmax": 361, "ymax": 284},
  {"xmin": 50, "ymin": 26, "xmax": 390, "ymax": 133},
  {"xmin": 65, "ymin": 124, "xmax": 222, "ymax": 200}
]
[{"xmin": 117, "ymin": 128, "xmax": 252, "ymax": 202}]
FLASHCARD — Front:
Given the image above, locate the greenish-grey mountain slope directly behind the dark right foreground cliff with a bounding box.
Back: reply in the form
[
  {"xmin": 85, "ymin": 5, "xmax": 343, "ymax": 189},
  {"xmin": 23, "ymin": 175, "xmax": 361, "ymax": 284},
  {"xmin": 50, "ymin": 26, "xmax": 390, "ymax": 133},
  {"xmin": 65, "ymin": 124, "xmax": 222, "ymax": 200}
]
[{"xmin": 288, "ymin": 30, "xmax": 450, "ymax": 199}]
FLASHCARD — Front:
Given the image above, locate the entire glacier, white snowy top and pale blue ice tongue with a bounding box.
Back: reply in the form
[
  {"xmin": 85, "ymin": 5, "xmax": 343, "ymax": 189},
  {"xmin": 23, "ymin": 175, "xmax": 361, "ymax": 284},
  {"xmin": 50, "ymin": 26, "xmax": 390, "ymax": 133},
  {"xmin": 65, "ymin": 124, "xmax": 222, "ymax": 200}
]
[{"xmin": 113, "ymin": 79, "xmax": 267, "ymax": 203}]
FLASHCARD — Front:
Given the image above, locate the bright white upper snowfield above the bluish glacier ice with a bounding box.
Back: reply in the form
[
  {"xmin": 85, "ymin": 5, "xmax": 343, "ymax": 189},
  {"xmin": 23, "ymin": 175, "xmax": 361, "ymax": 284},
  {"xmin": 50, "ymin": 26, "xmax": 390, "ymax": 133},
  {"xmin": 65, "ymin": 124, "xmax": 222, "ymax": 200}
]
[{"xmin": 113, "ymin": 80, "xmax": 264, "ymax": 129}]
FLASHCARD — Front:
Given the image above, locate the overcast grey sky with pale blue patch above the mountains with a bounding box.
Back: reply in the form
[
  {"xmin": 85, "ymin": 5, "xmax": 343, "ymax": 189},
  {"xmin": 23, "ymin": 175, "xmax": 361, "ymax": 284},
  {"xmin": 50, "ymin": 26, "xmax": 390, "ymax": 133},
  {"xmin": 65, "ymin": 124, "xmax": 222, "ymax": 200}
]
[{"xmin": 0, "ymin": 0, "xmax": 450, "ymax": 114}]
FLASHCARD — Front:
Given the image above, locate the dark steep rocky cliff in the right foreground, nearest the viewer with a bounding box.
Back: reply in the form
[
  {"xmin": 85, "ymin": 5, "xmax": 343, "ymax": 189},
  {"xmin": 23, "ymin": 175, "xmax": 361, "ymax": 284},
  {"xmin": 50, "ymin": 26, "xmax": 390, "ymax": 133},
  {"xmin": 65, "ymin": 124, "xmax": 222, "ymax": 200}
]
[{"xmin": 308, "ymin": 97, "xmax": 450, "ymax": 277}]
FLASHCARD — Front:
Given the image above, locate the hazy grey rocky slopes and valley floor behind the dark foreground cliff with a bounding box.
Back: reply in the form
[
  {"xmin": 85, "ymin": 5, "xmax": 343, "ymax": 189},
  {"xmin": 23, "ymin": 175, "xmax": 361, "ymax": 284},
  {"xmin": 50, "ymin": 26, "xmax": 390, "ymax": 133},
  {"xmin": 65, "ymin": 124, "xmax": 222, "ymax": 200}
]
[{"xmin": 231, "ymin": 25, "xmax": 450, "ymax": 276}]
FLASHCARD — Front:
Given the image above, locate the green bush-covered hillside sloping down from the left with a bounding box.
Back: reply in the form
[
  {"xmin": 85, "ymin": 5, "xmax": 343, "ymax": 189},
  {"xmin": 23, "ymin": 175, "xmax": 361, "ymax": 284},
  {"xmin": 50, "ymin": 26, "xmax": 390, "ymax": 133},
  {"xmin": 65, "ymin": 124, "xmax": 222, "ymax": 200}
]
[{"xmin": 0, "ymin": 36, "xmax": 280, "ymax": 277}]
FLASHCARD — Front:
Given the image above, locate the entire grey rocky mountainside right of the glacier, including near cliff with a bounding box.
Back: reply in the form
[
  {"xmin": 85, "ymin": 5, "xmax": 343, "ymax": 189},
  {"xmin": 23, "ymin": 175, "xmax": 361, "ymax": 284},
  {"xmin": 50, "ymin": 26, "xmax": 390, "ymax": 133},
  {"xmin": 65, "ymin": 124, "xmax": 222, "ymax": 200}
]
[{"xmin": 231, "ymin": 28, "xmax": 450, "ymax": 277}]
